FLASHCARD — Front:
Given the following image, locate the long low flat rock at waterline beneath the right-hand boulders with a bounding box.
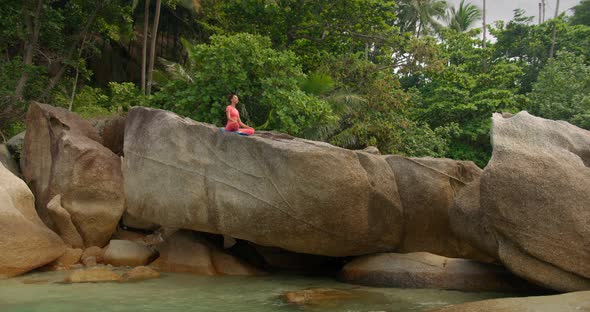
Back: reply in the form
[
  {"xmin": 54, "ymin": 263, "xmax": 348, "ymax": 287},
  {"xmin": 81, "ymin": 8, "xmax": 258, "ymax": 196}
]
[{"xmin": 340, "ymin": 252, "xmax": 534, "ymax": 292}]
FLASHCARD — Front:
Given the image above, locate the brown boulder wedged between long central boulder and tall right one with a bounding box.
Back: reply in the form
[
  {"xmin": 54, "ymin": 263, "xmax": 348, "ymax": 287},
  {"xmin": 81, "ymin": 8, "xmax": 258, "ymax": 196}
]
[{"xmin": 385, "ymin": 155, "xmax": 493, "ymax": 262}]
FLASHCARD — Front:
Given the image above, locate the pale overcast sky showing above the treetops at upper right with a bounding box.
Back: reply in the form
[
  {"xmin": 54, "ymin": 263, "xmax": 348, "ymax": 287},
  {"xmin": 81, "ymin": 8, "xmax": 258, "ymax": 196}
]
[{"xmin": 447, "ymin": 0, "xmax": 580, "ymax": 23}]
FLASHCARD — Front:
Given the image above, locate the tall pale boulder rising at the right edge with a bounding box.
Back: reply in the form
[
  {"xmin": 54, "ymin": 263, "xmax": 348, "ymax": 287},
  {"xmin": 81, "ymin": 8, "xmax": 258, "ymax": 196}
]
[{"xmin": 451, "ymin": 112, "xmax": 590, "ymax": 291}]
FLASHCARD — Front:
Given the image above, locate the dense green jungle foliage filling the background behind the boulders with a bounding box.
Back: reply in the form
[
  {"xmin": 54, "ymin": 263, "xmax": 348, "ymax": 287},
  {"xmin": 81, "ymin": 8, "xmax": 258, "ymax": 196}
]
[{"xmin": 0, "ymin": 0, "xmax": 590, "ymax": 166}]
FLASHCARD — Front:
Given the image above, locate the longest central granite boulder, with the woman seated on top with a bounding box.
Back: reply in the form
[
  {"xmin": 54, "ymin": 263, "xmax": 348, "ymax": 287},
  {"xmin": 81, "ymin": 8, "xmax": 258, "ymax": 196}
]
[{"xmin": 123, "ymin": 107, "xmax": 403, "ymax": 256}]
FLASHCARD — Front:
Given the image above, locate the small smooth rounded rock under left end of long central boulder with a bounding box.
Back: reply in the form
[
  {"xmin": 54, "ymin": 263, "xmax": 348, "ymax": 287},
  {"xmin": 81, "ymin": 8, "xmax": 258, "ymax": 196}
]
[{"xmin": 104, "ymin": 239, "xmax": 156, "ymax": 266}]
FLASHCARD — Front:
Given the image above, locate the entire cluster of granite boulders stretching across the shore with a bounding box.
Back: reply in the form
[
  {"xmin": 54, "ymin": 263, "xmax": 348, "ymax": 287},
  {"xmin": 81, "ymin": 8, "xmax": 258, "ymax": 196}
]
[{"xmin": 0, "ymin": 103, "xmax": 590, "ymax": 308}]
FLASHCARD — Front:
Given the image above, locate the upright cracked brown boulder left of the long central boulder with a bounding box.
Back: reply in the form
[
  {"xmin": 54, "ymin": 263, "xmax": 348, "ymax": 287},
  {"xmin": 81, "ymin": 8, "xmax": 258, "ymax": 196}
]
[{"xmin": 21, "ymin": 103, "xmax": 125, "ymax": 247}]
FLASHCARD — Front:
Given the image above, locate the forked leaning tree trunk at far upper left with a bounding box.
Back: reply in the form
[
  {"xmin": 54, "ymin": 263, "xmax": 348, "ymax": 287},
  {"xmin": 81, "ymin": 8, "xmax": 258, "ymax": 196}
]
[{"xmin": 14, "ymin": 0, "xmax": 43, "ymax": 100}]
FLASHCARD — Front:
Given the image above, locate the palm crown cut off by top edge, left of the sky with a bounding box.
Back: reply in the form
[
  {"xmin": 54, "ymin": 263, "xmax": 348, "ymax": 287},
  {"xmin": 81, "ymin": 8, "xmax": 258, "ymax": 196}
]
[{"xmin": 398, "ymin": 0, "xmax": 448, "ymax": 37}]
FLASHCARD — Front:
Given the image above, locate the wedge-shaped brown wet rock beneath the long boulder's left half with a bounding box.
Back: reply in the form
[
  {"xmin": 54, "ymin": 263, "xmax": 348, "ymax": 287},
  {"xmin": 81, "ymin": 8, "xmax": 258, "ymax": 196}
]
[{"xmin": 150, "ymin": 230, "xmax": 263, "ymax": 275}]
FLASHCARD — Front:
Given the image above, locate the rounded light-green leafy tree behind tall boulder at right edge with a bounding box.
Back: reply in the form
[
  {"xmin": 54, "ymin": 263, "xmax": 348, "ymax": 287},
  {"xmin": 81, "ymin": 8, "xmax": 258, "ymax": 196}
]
[{"xmin": 529, "ymin": 51, "xmax": 590, "ymax": 130}]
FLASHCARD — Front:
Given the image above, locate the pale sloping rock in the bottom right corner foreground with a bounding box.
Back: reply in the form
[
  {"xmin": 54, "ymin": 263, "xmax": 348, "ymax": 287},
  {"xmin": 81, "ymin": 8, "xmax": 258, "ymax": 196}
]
[{"xmin": 430, "ymin": 291, "xmax": 590, "ymax": 312}]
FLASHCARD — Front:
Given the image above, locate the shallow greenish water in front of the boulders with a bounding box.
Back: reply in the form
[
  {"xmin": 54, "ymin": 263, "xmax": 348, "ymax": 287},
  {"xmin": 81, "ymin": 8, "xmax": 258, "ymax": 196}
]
[{"xmin": 0, "ymin": 272, "xmax": 520, "ymax": 312}]
